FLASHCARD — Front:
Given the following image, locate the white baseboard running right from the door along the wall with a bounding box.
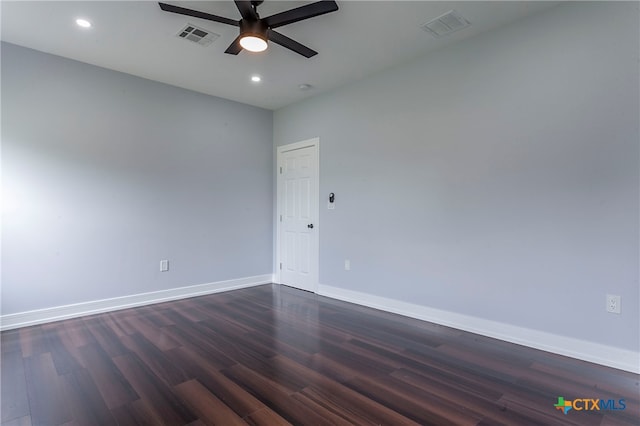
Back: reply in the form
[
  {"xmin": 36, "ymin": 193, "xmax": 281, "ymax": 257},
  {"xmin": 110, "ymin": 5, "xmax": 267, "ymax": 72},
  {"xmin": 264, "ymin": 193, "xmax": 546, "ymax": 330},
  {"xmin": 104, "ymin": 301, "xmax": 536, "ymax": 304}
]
[{"xmin": 318, "ymin": 284, "xmax": 640, "ymax": 374}]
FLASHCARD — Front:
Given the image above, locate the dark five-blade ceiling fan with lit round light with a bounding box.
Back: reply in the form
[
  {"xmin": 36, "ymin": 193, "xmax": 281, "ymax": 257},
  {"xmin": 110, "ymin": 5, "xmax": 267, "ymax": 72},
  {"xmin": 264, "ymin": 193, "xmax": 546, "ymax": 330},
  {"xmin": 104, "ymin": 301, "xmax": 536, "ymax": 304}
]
[{"xmin": 158, "ymin": 0, "xmax": 338, "ymax": 58}]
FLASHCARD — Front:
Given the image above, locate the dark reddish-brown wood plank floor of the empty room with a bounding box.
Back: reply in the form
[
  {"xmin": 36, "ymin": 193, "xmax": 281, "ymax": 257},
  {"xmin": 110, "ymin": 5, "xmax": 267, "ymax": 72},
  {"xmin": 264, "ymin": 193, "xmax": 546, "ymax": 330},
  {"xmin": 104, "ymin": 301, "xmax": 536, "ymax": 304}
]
[{"xmin": 1, "ymin": 285, "xmax": 640, "ymax": 425}]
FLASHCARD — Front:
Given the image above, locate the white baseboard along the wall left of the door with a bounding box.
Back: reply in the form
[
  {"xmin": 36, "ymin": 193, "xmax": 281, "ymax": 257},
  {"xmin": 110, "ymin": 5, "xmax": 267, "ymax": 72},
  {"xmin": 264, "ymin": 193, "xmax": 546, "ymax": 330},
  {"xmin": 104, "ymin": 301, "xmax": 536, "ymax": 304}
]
[{"xmin": 0, "ymin": 274, "xmax": 273, "ymax": 330}]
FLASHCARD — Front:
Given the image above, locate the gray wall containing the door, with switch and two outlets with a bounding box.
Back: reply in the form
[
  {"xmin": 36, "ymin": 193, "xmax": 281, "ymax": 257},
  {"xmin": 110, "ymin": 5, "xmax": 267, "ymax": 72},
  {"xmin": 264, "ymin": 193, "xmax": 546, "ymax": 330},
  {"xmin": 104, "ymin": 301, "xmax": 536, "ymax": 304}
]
[{"xmin": 274, "ymin": 2, "xmax": 640, "ymax": 351}]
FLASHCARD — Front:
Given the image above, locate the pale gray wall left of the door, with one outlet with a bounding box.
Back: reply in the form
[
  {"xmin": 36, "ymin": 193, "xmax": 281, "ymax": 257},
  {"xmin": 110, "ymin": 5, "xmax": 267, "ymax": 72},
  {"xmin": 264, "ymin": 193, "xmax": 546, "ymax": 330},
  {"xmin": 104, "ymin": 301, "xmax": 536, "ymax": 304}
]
[{"xmin": 2, "ymin": 43, "xmax": 273, "ymax": 314}]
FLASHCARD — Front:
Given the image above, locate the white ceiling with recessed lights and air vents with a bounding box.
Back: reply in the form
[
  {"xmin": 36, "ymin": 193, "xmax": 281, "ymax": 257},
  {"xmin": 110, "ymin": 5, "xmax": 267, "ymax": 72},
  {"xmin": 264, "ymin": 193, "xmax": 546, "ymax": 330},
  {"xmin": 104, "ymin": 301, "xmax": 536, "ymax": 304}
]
[{"xmin": 0, "ymin": 0, "xmax": 558, "ymax": 109}]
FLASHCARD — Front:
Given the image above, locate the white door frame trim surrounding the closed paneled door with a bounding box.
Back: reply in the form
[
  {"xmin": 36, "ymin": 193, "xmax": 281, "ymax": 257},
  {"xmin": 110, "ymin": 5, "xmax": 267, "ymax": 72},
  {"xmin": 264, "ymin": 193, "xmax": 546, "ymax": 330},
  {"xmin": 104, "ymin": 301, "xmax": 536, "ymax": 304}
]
[{"xmin": 274, "ymin": 137, "xmax": 320, "ymax": 293}]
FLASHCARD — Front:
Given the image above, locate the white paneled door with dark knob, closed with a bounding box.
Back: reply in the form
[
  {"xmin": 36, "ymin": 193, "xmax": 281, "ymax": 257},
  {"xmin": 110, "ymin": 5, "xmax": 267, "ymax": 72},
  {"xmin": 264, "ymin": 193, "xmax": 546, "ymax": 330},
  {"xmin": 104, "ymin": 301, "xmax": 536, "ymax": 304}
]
[{"xmin": 276, "ymin": 139, "xmax": 319, "ymax": 292}]
